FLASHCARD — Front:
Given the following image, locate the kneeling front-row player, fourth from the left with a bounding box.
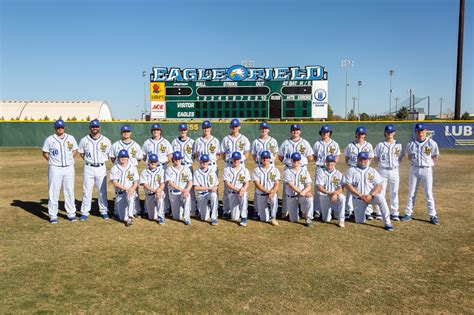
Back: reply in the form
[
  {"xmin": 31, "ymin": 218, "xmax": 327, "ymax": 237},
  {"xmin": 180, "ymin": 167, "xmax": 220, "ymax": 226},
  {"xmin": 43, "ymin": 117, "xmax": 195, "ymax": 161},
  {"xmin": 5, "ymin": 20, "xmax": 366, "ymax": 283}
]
[{"xmin": 193, "ymin": 154, "xmax": 219, "ymax": 225}]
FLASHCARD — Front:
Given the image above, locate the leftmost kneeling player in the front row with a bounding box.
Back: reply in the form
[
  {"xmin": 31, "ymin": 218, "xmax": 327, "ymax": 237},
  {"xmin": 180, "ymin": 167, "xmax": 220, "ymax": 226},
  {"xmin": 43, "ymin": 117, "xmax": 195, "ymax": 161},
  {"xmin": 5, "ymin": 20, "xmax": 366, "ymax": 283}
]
[{"xmin": 110, "ymin": 149, "xmax": 139, "ymax": 226}]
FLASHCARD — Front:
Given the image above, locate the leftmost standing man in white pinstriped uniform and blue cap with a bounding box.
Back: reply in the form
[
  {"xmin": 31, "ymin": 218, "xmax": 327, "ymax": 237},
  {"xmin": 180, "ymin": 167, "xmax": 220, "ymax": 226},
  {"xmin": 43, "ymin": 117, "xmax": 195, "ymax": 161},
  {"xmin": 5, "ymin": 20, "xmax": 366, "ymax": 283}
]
[{"xmin": 43, "ymin": 119, "xmax": 77, "ymax": 224}]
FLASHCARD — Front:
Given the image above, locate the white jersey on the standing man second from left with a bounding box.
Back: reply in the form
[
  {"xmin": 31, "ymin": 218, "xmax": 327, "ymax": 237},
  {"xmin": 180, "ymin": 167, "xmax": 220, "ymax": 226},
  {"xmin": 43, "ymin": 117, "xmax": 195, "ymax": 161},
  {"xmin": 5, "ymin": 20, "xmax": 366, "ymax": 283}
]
[{"xmin": 77, "ymin": 135, "xmax": 112, "ymax": 164}]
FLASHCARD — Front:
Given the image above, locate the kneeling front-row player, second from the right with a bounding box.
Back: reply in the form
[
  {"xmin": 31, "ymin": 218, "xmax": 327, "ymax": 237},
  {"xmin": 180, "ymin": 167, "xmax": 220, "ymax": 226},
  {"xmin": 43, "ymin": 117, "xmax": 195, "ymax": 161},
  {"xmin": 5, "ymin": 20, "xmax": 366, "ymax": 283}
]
[{"xmin": 315, "ymin": 155, "xmax": 346, "ymax": 228}]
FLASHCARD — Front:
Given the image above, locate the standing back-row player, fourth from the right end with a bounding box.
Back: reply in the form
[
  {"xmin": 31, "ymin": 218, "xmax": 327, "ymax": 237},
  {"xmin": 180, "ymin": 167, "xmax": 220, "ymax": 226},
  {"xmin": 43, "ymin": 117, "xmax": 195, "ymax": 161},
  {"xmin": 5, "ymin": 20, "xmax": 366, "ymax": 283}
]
[{"xmin": 313, "ymin": 125, "xmax": 341, "ymax": 218}]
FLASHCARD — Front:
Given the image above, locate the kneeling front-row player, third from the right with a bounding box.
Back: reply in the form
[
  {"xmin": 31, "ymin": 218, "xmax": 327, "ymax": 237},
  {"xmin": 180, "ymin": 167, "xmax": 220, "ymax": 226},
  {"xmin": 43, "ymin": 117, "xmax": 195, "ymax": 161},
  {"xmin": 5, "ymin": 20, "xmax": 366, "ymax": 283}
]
[{"xmin": 283, "ymin": 152, "xmax": 313, "ymax": 227}]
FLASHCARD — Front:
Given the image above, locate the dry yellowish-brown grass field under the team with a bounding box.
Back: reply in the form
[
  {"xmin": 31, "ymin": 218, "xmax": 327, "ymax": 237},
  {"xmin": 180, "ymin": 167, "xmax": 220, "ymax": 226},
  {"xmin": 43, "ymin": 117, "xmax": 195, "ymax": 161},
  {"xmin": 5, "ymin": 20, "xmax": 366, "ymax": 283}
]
[{"xmin": 0, "ymin": 148, "xmax": 474, "ymax": 313}]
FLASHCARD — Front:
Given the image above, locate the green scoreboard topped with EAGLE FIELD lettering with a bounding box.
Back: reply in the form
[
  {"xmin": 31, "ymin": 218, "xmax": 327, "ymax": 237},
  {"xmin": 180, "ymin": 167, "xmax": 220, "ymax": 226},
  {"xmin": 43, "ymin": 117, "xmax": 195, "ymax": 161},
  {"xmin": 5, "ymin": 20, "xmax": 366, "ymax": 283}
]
[{"xmin": 150, "ymin": 65, "xmax": 328, "ymax": 119}]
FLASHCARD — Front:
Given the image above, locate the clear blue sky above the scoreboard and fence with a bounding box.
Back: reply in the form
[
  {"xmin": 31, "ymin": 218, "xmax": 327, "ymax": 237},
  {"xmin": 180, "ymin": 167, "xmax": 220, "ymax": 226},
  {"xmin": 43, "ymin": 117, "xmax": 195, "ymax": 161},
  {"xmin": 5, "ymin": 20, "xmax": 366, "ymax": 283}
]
[{"xmin": 0, "ymin": 0, "xmax": 474, "ymax": 119}]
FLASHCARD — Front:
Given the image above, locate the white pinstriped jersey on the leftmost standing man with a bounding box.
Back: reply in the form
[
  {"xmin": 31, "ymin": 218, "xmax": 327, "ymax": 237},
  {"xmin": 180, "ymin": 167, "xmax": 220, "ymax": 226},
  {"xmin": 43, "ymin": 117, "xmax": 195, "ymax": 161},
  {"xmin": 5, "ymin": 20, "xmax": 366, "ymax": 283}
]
[{"xmin": 43, "ymin": 133, "xmax": 77, "ymax": 167}]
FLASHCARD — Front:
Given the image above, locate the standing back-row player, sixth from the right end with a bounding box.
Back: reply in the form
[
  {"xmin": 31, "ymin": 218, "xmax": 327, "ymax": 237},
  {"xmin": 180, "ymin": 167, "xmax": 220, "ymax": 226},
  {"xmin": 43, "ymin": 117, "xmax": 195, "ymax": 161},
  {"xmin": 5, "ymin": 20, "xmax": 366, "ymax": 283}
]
[{"xmin": 251, "ymin": 121, "xmax": 278, "ymax": 222}]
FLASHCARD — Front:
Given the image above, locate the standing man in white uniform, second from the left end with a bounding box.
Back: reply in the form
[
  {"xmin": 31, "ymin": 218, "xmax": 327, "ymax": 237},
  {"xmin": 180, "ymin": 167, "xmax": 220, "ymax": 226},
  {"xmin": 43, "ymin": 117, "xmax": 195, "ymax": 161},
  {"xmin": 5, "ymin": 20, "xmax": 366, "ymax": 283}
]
[{"xmin": 78, "ymin": 119, "xmax": 112, "ymax": 221}]
